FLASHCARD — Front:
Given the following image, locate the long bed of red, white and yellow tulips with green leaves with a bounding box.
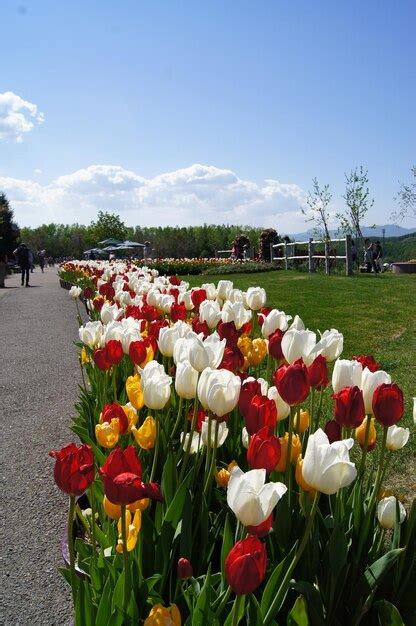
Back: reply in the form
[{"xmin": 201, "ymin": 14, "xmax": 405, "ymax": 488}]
[{"xmin": 51, "ymin": 262, "xmax": 416, "ymax": 626}]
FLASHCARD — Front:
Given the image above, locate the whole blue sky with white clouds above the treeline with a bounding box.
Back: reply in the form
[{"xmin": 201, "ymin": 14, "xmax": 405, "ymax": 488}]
[{"xmin": 0, "ymin": 0, "xmax": 416, "ymax": 232}]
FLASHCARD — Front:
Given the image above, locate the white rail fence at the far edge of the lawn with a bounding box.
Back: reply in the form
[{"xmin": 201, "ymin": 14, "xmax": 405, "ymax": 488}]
[{"xmin": 270, "ymin": 235, "xmax": 352, "ymax": 276}]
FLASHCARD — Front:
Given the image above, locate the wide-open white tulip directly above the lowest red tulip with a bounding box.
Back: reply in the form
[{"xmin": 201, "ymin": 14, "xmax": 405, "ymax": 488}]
[{"xmin": 227, "ymin": 467, "xmax": 287, "ymax": 526}]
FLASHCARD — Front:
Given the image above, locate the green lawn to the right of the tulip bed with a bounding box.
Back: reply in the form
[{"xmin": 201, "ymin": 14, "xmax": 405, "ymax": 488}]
[{"xmin": 183, "ymin": 271, "xmax": 416, "ymax": 499}]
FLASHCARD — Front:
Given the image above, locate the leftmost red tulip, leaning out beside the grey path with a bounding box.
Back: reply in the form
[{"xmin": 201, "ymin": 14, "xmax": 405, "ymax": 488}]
[{"xmin": 49, "ymin": 443, "xmax": 94, "ymax": 496}]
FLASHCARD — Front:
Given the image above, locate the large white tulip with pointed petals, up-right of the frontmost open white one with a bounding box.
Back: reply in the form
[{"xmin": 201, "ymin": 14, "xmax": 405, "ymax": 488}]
[{"xmin": 302, "ymin": 428, "xmax": 357, "ymax": 495}]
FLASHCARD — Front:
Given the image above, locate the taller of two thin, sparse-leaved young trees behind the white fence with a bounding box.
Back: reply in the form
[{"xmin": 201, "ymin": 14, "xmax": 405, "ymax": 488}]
[{"xmin": 336, "ymin": 165, "xmax": 374, "ymax": 239}]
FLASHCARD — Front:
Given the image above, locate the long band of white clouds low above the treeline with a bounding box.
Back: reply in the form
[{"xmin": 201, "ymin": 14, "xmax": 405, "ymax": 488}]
[{"xmin": 0, "ymin": 164, "xmax": 305, "ymax": 232}]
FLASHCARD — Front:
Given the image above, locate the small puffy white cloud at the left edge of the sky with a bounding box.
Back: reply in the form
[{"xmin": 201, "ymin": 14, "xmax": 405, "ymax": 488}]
[{"xmin": 0, "ymin": 91, "xmax": 44, "ymax": 143}]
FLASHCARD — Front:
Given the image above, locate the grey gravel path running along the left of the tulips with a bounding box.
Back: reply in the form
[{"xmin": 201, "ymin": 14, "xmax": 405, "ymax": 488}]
[{"xmin": 0, "ymin": 268, "xmax": 80, "ymax": 626}]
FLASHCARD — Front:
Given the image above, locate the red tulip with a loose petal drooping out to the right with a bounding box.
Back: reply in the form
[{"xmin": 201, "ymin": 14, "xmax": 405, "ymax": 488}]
[{"xmin": 99, "ymin": 446, "xmax": 163, "ymax": 504}]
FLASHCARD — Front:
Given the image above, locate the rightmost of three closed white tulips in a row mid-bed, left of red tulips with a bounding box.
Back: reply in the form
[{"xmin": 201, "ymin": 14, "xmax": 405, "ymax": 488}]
[{"xmin": 197, "ymin": 367, "xmax": 241, "ymax": 417}]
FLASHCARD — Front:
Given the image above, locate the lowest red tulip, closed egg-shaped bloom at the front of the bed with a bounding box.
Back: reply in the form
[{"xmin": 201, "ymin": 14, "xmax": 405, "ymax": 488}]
[{"xmin": 225, "ymin": 537, "xmax": 267, "ymax": 595}]
